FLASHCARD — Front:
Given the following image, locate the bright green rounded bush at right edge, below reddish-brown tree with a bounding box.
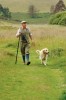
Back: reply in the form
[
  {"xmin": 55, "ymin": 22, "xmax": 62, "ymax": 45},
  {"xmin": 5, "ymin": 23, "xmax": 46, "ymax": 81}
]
[{"xmin": 49, "ymin": 11, "xmax": 66, "ymax": 25}]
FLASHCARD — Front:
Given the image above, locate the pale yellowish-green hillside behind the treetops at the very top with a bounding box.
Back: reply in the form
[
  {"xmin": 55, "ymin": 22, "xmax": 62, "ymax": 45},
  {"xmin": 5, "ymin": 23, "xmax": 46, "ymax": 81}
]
[{"xmin": 0, "ymin": 0, "xmax": 66, "ymax": 12}]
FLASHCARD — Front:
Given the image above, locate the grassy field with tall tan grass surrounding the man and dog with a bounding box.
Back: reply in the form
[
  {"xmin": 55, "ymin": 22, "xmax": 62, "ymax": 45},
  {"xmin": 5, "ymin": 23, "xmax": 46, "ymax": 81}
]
[{"xmin": 0, "ymin": 21, "xmax": 66, "ymax": 100}]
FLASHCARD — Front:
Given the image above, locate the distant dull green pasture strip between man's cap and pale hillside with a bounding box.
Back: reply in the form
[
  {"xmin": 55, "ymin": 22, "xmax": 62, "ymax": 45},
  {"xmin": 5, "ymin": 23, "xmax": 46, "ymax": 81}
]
[{"xmin": 11, "ymin": 12, "xmax": 51, "ymax": 24}]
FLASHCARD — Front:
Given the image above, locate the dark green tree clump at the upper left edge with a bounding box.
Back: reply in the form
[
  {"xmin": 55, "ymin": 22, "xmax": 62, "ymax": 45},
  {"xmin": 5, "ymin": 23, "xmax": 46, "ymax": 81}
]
[{"xmin": 0, "ymin": 4, "xmax": 11, "ymax": 19}]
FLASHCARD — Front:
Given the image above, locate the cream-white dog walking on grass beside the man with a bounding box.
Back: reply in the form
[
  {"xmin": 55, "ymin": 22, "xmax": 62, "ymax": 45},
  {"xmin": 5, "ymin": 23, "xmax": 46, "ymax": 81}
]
[{"xmin": 36, "ymin": 48, "xmax": 49, "ymax": 65}]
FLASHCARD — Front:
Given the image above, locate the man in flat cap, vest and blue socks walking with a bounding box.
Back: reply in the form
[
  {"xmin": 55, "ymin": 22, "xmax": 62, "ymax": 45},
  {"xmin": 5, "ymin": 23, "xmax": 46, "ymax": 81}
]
[{"xmin": 16, "ymin": 21, "xmax": 32, "ymax": 65}]
